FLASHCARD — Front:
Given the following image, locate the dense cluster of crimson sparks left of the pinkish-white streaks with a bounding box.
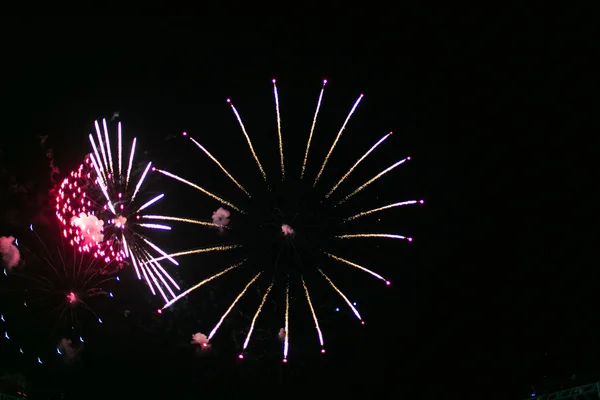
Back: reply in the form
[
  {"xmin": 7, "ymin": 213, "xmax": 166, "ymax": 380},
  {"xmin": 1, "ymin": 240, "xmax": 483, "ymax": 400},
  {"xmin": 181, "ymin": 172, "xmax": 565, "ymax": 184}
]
[{"xmin": 56, "ymin": 158, "xmax": 125, "ymax": 264}]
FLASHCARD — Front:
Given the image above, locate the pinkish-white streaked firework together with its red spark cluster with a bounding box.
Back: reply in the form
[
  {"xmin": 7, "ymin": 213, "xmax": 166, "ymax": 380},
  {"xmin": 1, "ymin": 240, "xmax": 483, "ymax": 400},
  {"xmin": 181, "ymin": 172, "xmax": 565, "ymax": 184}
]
[{"xmin": 56, "ymin": 119, "xmax": 182, "ymax": 302}]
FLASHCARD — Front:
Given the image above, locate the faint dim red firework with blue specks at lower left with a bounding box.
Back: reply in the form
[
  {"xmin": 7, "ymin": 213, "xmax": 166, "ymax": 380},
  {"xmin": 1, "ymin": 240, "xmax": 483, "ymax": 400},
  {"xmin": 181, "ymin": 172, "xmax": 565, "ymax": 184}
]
[{"xmin": 0, "ymin": 225, "xmax": 118, "ymax": 364}]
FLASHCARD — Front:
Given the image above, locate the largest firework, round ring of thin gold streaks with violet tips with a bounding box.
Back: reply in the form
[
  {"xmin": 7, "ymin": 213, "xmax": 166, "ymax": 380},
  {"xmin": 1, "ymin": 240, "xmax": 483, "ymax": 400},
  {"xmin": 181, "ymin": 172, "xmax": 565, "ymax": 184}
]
[{"xmin": 156, "ymin": 80, "xmax": 423, "ymax": 362}]
